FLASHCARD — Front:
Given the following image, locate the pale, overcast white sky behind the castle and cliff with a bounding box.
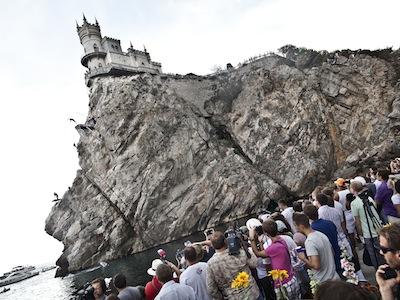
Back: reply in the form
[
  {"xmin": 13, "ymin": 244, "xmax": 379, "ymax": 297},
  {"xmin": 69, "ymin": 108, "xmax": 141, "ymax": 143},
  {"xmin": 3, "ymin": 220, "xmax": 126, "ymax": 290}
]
[{"xmin": 0, "ymin": 0, "xmax": 400, "ymax": 273}]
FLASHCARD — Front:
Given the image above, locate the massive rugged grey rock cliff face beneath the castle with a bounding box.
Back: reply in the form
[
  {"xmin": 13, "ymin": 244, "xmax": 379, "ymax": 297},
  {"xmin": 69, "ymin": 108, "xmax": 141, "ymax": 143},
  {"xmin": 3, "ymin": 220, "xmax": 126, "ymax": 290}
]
[{"xmin": 46, "ymin": 49, "xmax": 400, "ymax": 275}]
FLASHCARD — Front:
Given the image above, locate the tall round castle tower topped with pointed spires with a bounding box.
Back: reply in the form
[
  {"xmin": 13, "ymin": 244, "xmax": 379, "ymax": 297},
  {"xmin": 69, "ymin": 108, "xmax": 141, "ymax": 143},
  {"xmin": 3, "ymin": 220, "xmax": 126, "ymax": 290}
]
[{"xmin": 77, "ymin": 15, "xmax": 106, "ymax": 70}]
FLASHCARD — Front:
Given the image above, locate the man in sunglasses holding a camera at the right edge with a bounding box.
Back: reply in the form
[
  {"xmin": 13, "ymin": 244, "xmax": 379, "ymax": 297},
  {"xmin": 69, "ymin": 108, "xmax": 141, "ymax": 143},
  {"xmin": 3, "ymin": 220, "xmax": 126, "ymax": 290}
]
[{"xmin": 375, "ymin": 223, "xmax": 400, "ymax": 300}]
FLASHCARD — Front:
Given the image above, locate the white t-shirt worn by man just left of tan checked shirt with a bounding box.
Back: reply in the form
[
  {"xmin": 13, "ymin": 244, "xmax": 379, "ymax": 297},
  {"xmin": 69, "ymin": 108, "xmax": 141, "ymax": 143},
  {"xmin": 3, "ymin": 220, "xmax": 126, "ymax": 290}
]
[{"xmin": 179, "ymin": 262, "xmax": 211, "ymax": 300}]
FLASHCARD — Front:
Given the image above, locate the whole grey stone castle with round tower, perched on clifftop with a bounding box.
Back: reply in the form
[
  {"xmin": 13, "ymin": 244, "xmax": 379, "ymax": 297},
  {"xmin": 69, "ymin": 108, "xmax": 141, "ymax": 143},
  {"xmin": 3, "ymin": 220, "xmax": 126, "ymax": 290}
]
[{"xmin": 76, "ymin": 15, "xmax": 162, "ymax": 85}]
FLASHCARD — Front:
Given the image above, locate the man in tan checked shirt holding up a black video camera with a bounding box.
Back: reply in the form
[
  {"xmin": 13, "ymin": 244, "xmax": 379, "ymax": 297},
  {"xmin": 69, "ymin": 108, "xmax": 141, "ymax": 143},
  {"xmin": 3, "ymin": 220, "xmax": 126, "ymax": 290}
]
[{"xmin": 207, "ymin": 231, "xmax": 260, "ymax": 300}]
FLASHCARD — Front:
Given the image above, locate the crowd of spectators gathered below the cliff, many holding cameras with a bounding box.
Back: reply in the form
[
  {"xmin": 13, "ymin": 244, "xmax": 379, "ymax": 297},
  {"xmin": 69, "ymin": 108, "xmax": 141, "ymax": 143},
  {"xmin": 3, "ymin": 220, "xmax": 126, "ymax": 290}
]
[{"xmin": 86, "ymin": 159, "xmax": 400, "ymax": 300}]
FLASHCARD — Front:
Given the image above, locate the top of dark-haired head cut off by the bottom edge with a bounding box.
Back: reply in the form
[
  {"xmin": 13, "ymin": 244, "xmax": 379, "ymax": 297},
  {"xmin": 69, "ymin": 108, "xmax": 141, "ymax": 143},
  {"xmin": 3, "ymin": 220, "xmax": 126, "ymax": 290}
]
[{"xmin": 314, "ymin": 280, "xmax": 375, "ymax": 300}]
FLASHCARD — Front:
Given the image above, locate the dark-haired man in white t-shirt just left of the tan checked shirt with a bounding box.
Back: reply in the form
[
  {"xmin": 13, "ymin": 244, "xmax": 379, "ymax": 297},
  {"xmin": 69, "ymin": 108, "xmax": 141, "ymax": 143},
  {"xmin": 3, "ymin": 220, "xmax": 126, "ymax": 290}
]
[{"xmin": 179, "ymin": 245, "xmax": 211, "ymax": 300}]
